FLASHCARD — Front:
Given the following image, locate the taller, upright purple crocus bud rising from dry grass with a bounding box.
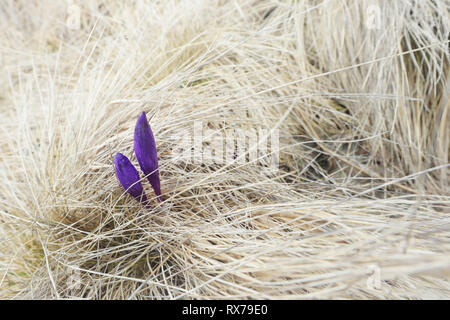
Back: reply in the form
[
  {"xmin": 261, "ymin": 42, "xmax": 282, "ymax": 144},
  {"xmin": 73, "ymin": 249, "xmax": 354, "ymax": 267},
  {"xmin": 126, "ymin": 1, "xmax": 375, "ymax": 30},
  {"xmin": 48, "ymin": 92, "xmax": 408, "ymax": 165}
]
[{"xmin": 134, "ymin": 112, "xmax": 161, "ymax": 202}]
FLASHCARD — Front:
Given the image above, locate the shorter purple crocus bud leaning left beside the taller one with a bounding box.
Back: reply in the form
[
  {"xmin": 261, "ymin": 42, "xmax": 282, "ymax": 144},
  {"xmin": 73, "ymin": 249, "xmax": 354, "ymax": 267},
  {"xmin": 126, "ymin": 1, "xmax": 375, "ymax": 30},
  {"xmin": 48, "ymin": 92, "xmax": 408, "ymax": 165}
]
[{"xmin": 113, "ymin": 153, "xmax": 147, "ymax": 202}]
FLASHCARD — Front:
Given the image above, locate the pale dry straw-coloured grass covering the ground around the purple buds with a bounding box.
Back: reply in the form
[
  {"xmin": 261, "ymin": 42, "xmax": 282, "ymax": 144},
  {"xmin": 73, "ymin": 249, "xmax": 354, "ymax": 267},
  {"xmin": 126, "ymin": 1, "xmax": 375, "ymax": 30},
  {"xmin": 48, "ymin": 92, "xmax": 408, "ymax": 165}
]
[{"xmin": 0, "ymin": 0, "xmax": 450, "ymax": 299}]
